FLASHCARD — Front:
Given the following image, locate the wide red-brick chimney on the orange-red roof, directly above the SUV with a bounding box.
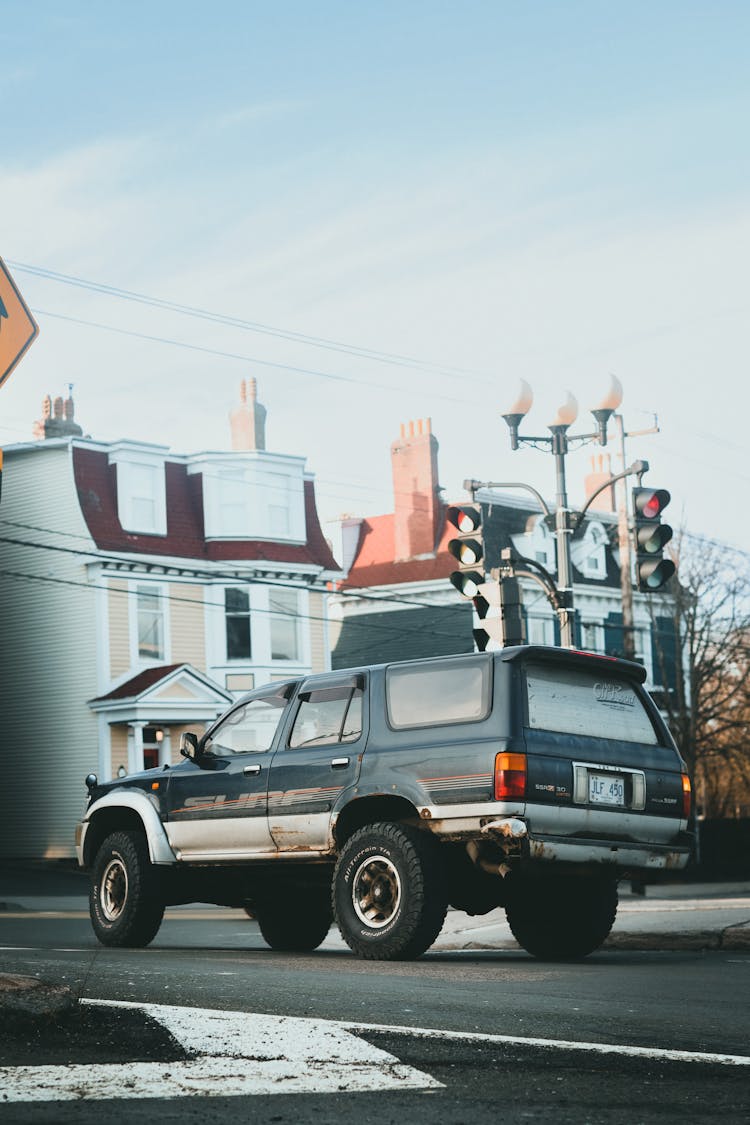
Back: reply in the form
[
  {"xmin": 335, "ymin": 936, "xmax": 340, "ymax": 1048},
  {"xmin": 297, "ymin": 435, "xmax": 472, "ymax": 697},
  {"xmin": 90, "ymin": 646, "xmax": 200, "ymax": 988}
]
[{"xmin": 390, "ymin": 419, "xmax": 442, "ymax": 560}]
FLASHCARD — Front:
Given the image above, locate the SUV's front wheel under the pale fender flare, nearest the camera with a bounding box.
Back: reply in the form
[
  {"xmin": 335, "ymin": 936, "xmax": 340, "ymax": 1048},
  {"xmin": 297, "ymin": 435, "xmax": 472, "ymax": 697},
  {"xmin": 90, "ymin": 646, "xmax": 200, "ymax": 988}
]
[{"xmin": 89, "ymin": 831, "xmax": 164, "ymax": 948}]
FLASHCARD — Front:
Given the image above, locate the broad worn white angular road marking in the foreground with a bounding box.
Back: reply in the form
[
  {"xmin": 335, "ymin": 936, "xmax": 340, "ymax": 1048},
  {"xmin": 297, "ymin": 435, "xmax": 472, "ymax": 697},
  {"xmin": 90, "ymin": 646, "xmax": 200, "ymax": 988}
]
[{"xmin": 0, "ymin": 1000, "xmax": 442, "ymax": 1104}]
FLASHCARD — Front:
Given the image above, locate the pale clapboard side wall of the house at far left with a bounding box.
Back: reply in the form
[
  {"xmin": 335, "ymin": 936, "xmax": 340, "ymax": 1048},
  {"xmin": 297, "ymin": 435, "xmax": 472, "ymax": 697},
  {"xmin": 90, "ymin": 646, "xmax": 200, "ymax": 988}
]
[{"xmin": 0, "ymin": 442, "xmax": 103, "ymax": 858}]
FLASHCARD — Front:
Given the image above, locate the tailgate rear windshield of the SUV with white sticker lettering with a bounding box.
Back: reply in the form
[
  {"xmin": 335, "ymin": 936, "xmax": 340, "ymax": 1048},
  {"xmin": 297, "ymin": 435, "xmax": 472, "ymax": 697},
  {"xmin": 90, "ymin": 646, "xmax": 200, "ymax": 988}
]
[{"xmin": 526, "ymin": 664, "xmax": 659, "ymax": 746}]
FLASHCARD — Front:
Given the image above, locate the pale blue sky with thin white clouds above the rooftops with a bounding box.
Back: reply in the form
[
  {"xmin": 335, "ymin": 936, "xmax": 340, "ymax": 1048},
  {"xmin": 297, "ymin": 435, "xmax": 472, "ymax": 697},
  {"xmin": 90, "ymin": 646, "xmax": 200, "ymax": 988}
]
[{"xmin": 0, "ymin": 0, "xmax": 750, "ymax": 549}]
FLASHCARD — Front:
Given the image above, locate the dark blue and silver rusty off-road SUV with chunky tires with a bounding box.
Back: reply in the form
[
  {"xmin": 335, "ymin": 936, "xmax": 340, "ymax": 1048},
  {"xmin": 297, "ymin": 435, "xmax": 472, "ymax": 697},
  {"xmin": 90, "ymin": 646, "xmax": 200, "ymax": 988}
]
[{"xmin": 76, "ymin": 646, "xmax": 690, "ymax": 960}]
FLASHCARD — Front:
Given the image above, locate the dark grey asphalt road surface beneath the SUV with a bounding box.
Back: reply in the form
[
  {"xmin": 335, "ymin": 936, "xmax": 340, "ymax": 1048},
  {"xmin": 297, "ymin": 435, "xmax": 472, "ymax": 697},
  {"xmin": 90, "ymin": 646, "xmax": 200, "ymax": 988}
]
[{"xmin": 0, "ymin": 868, "xmax": 750, "ymax": 1125}]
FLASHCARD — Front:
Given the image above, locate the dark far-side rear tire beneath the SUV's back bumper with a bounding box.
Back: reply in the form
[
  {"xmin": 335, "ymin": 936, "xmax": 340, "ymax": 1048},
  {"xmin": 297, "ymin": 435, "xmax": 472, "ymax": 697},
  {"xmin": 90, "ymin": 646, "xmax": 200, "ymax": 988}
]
[{"xmin": 505, "ymin": 874, "xmax": 617, "ymax": 961}]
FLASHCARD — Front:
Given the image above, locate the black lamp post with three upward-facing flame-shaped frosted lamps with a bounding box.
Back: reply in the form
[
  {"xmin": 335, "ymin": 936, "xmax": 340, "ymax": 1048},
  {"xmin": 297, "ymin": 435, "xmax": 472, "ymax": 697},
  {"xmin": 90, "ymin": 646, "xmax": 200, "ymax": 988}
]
[{"xmin": 503, "ymin": 375, "xmax": 623, "ymax": 648}]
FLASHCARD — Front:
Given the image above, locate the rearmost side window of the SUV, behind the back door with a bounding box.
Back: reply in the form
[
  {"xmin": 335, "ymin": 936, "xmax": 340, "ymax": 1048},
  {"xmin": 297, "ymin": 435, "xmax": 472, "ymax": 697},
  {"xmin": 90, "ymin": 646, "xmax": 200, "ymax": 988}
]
[{"xmin": 386, "ymin": 656, "xmax": 491, "ymax": 730}]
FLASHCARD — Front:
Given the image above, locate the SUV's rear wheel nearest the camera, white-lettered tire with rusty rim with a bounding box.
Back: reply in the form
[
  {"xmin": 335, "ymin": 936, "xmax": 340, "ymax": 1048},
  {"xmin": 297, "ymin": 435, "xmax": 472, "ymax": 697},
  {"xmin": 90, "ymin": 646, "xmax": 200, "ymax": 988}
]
[{"xmin": 333, "ymin": 822, "xmax": 448, "ymax": 961}]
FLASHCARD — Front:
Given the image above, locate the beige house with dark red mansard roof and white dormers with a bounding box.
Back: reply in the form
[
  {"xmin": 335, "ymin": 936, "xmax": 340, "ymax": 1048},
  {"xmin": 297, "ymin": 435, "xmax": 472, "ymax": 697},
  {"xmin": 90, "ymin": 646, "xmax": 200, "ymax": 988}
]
[{"xmin": 0, "ymin": 380, "xmax": 341, "ymax": 857}]
